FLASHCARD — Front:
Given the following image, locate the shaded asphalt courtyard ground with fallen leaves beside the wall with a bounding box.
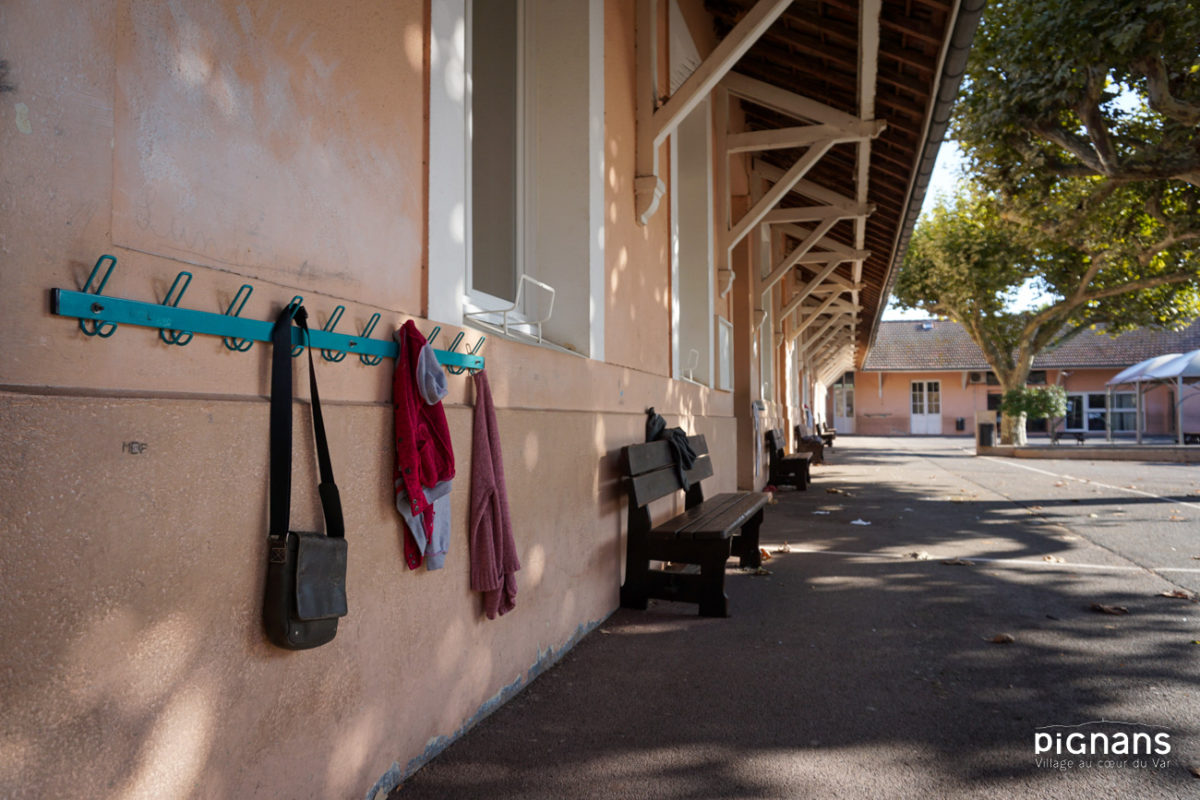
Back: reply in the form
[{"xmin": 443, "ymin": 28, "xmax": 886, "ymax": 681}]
[{"xmin": 391, "ymin": 437, "xmax": 1200, "ymax": 800}]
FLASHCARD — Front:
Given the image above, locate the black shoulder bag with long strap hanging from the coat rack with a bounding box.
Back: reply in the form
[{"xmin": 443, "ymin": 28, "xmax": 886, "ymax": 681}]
[{"xmin": 263, "ymin": 305, "xmax": 347, "ymax": 650}]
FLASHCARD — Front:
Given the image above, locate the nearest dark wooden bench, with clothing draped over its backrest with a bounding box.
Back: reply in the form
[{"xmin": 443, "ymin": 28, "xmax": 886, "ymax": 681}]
[{"xmin": 620, "ymin": 437, "xmax": 767, "ymax": 616}]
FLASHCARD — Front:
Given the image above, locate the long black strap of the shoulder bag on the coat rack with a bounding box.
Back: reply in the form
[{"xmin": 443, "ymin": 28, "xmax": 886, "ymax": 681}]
[{"xmin": 269, "ymin": 305, "xmax": 346, "ymax": 539}]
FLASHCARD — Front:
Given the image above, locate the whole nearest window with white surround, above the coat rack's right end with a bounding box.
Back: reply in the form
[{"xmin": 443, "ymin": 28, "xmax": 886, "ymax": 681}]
[{"xmin": 428, "ymin": 0, "xmax": 605, "ymax": 359}]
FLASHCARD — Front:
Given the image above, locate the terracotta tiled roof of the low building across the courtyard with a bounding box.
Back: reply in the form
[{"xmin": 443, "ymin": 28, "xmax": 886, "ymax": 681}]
[{"xmin": 863, "ymin": 319, "xmax": 1200, "ymax": 372}]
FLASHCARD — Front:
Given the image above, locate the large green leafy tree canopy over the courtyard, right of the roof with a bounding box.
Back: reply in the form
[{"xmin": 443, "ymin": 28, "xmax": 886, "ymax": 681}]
[{"xmin": 894, "ymin": 0, "xmax": 1200, "ymax": 443}]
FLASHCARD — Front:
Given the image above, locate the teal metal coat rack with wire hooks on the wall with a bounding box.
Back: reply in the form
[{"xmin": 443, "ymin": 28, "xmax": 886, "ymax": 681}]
[{"xmin": 50, "ymin": 255, "xmax": 486, "ymax": 374}]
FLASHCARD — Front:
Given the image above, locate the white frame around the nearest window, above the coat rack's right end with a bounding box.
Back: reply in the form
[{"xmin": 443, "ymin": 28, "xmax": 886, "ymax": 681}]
[{"xmin": 426, "ymin": 0, "xmax": 606, "ymax": 361}]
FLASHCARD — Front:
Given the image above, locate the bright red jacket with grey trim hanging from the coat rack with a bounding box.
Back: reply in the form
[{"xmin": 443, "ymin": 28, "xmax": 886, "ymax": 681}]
[{"xmin": 392, "ymin": 320, "xmax": 454, "ymax": 570}]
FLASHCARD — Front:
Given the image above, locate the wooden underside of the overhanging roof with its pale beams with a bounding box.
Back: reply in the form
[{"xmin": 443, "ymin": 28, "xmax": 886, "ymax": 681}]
[{"xmin": 704, "ymin": 0, "xmax": 984, "ymax": 368}]
